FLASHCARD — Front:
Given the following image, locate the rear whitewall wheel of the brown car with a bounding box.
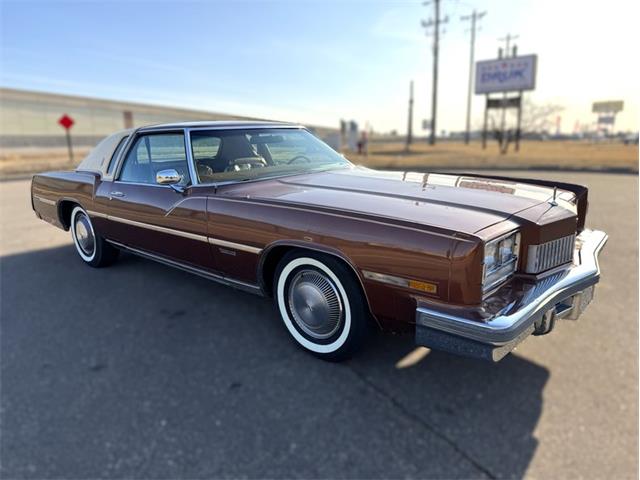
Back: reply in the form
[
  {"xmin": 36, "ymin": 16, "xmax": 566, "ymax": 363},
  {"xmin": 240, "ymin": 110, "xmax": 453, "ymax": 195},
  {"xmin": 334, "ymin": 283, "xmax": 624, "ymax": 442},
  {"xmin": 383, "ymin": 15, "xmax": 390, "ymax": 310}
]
[{"xmin": 70, "ymin": 206, "xmax": 119, "ymax": 268}]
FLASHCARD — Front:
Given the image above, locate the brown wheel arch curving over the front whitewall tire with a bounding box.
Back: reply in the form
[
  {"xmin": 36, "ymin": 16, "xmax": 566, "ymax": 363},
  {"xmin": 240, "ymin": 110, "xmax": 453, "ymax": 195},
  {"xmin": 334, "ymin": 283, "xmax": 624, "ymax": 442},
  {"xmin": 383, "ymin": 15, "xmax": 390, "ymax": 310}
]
[{"xmin": 258, "ymin": 240, "xmax": 380, "ymax": 327}]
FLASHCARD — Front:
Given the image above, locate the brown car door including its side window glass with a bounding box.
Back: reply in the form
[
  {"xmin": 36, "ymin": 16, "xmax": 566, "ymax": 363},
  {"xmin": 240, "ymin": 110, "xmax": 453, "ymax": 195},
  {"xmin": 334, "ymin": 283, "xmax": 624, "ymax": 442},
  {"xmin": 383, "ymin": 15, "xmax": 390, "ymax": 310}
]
[{"xmin": 96, "ymin": 130, "xmax": 214, "ymax": 269}]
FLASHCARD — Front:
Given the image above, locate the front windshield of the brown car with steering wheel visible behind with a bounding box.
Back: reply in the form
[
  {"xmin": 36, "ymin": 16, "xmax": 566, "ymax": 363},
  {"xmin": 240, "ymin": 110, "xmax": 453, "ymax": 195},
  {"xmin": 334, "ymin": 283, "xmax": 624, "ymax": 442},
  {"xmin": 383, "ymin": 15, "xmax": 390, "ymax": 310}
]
[{"xmin": 191, "ymin": 128, "xmax": 351, "ymax": 183}]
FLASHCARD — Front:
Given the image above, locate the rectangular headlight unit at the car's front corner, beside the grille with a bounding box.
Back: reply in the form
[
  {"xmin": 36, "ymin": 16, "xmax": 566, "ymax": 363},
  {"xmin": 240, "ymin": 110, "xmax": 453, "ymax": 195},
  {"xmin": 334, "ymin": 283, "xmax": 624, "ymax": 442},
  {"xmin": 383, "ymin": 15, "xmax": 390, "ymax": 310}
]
[{"xmin": 482, "ymin": 232, "xmax": 520, "ymax": 292}]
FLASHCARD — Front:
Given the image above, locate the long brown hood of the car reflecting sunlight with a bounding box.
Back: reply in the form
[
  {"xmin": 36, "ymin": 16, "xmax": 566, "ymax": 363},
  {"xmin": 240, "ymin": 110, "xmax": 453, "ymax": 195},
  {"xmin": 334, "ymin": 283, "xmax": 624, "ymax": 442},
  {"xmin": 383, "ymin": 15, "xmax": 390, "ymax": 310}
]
[{"xmin": 228, "ymin": 167, "xmax": 573, "ymax": 234}]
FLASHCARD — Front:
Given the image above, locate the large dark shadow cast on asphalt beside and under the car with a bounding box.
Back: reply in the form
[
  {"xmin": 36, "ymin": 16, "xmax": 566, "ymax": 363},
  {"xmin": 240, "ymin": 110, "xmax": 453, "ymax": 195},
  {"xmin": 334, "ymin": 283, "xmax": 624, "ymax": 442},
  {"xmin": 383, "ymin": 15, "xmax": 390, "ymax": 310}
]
[{"xmin": 0, "ymin": 246, "xmax": 549, "ymax": 478}]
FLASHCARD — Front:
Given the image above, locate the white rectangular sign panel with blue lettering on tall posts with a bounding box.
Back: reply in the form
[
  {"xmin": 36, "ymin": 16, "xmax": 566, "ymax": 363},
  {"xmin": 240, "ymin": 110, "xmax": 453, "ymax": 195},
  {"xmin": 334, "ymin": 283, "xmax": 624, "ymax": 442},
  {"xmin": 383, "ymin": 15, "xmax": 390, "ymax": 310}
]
[{"xmin": 475, "ymin": 55, "xmax": 538, "ymax": 94}]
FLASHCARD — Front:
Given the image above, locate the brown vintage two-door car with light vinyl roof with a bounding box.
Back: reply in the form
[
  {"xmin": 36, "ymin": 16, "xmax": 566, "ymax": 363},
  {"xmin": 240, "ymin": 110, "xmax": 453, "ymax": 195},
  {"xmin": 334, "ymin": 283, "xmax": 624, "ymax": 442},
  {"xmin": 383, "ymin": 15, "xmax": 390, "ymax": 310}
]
[{"xmin": 31, "ymin": 122, "xmax": 607, "ymax": 361}]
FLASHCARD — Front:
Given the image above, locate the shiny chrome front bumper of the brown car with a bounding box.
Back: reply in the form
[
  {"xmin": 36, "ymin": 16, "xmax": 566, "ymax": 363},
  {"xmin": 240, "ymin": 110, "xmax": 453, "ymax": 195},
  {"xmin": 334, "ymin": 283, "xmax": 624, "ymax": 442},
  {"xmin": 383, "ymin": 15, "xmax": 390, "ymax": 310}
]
[{"xmin": 416, "ymin": 230, "xmax": 608, "ymax": 361}]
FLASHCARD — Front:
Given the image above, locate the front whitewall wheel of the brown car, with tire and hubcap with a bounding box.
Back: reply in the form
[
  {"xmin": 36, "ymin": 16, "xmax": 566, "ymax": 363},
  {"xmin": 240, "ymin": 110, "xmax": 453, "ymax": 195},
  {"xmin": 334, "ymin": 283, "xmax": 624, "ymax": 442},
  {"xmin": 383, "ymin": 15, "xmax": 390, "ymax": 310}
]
[{"xmin": 274, "ymin": 251, "xmax": 368, "ymax": 360}]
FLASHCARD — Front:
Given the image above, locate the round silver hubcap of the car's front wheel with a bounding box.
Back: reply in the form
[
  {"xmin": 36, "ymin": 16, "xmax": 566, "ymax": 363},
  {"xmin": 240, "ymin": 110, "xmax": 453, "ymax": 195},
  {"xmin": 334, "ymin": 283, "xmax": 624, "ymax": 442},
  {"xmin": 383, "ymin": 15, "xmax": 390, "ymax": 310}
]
[{"xmin": 289, "ymin": 270, "xmax": 342, "ymax": 340}]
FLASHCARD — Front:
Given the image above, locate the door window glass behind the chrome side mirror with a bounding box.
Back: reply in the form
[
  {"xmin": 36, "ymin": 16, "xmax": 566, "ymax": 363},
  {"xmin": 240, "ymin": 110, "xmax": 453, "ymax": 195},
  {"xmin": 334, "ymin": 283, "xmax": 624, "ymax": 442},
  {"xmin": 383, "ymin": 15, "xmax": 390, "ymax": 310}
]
[{"xmin": 118, "ymin": 133, "xmax": 190, "ymax": 185}]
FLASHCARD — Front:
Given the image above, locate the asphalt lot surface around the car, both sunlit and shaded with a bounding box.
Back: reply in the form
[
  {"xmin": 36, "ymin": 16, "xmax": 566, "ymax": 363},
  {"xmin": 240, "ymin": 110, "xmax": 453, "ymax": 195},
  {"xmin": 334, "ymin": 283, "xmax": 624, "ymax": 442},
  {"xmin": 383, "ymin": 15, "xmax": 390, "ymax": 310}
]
[{"xmin": 0, "ymin": 172, "xmax": 638, "ymax": 479}]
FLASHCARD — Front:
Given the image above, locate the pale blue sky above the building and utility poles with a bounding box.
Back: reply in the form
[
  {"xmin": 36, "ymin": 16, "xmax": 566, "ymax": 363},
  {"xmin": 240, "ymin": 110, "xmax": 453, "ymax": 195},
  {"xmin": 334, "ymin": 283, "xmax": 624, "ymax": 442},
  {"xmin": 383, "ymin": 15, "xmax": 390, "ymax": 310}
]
[{"xmin": 0, "ymin": 0, "xmax": 640, "ymax": 131}]
